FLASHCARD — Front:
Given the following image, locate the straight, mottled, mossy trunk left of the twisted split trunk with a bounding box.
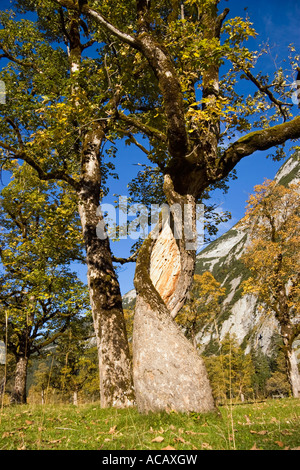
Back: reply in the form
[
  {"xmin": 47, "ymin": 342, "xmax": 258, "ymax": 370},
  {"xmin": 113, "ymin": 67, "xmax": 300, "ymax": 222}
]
[{"xmin": 78, "ymin": 123, "xmax": 134, "ymax": 407}]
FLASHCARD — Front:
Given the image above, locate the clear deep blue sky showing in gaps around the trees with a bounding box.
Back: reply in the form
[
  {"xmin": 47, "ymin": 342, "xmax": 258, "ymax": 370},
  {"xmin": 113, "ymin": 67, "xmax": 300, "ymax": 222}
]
[{"xmin": 0, "ymin": 0, "xmax": 300, "ymax": 294}]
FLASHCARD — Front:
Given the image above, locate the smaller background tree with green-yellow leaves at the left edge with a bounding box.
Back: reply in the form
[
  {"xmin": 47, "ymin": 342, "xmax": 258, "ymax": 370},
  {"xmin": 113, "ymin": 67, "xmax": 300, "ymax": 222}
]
[{"xmin": 0, "ymin": 163, "xmax": 88, "ymax": 403}]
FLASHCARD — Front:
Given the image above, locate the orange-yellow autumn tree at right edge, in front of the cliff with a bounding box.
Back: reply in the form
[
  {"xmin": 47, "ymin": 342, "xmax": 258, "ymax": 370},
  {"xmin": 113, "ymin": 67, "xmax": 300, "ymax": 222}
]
[{"xmin": 242, "ymin": 181, "xmax": 300, "ymax": 396}]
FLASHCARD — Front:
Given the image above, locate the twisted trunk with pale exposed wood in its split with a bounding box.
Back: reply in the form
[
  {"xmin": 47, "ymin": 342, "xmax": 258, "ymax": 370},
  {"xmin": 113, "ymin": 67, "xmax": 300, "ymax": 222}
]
[{"xmin": 133, "ymin": 177, "xmax": 215, "ymax": 413}]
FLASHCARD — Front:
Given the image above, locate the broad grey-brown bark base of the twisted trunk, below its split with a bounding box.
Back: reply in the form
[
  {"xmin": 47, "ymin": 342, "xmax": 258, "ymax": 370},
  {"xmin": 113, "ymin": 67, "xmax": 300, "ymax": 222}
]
[{"xmin": 133, "ymin": 290, "xmax": 215, "ymax": 413}]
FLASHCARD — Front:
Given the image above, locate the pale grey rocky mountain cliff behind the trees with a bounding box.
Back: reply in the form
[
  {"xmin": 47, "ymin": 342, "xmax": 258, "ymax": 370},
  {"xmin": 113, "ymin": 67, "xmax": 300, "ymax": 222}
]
[{"xmin": 123, "ymin": 153, "xmax": 300, "ymax": 354}]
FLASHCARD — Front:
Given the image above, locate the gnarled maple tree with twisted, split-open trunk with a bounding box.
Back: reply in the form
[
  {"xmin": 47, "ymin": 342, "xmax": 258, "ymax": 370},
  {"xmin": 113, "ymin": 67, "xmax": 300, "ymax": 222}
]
[{"xmin": 70, "ymin": 0, "xmax": 300, "ymax": 410}]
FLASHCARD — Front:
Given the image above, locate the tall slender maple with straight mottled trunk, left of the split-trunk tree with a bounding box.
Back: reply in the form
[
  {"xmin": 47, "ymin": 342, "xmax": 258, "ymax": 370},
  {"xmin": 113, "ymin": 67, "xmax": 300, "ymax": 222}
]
[{"xmin": 0, "ymin": 1, "xmax": 133, "ymax": 407}]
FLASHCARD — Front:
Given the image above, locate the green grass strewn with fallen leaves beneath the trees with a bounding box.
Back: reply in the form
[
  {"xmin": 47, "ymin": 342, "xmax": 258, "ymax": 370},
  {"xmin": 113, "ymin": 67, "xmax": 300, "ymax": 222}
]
[{"xmin": 0, "ymin": 399, "xmax": 300, "ymax": 450}]
